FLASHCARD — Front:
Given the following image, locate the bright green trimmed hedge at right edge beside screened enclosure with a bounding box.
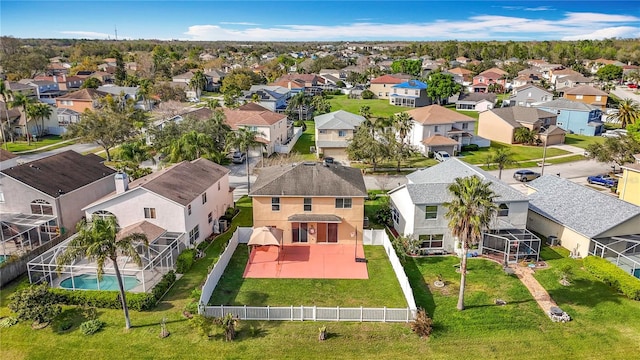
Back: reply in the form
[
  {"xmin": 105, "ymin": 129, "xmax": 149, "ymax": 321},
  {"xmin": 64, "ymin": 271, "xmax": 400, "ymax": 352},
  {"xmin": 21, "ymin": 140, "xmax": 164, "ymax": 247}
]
[{"xmin": 583, "ymin": 256, "xmax": 640, "ymax": 300}]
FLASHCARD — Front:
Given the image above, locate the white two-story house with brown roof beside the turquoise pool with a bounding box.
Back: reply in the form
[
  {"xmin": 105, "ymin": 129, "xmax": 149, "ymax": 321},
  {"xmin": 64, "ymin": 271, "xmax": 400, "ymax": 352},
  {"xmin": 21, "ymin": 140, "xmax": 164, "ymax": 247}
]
[{"xmin": 83, "ymin": 158, "xmax": 233, "ymax": 246}]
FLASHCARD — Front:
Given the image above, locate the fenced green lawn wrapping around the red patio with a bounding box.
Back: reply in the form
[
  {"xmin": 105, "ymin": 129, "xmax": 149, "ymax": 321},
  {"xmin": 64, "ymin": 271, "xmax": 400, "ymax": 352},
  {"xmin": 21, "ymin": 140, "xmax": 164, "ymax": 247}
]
[{"xmin": 209, "ymin": 245, "xmax": 407, "ymax": 308}]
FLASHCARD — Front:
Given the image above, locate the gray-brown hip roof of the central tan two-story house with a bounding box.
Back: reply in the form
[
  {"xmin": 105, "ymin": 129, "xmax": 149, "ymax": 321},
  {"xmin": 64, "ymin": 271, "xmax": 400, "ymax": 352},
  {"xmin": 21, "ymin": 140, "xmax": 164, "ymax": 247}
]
[{"xmin": 250, "ymin": 162, "xmax": 367, "ymax": 197}]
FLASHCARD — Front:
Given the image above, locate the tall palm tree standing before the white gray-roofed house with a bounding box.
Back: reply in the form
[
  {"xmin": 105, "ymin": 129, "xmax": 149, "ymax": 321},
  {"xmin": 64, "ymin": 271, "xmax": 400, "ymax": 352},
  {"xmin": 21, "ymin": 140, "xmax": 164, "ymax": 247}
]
[{"xmin": 444, "ymin": 175, "xmax": 498, "ymax": 310}]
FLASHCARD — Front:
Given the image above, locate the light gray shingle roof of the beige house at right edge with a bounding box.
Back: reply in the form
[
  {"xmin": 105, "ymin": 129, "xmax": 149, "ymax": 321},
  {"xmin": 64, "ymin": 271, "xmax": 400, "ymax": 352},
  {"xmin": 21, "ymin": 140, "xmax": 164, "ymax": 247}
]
[{"xmin": 528, "ymin": 175, "xmax": 640, "ymax": 238}]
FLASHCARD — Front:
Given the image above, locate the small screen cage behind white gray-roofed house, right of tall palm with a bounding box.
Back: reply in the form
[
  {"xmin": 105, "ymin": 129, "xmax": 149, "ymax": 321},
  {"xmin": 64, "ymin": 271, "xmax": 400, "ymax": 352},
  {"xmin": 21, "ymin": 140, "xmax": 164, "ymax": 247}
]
[{"xmin": 481, "ymin": 229, "xmax": 540, "ymax": 264}]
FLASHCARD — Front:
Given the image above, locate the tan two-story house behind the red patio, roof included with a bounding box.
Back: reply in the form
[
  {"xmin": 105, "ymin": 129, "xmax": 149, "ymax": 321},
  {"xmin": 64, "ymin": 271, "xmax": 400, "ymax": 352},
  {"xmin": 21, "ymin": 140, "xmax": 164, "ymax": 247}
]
[{"xmin": 249, "ymin": 162, "xmax": 367, "ymax": 244}]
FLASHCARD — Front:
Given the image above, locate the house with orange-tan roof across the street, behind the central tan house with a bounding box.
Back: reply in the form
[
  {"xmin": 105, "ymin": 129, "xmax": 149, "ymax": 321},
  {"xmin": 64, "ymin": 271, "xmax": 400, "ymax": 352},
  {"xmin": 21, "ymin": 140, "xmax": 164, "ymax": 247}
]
[{"xmin": 224, "ymin": 103, "xmax": 293, "ymax": 156}]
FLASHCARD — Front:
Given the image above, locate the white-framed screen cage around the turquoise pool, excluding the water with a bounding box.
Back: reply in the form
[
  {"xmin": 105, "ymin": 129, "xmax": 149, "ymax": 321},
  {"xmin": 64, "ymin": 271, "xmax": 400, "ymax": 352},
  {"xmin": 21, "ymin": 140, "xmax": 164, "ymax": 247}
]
[{"xmin": 27, "ymin": 232, "xmax": 186, "ymax": 292}]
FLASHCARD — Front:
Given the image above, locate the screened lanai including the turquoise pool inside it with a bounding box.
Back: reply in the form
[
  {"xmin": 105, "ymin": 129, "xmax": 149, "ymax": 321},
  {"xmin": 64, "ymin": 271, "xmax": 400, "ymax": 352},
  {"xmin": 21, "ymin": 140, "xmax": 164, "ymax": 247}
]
[{"xmin": 27, "ymin": 223, "xmax": 186, "ymax": 292}]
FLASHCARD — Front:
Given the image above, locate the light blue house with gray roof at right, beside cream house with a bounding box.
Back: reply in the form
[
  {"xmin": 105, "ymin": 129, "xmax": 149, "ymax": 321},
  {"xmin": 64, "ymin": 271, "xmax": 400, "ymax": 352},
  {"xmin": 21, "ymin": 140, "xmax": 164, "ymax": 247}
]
[{"xmin": 534, "ymin": 99, "xmax": 604, "ymax": 136}]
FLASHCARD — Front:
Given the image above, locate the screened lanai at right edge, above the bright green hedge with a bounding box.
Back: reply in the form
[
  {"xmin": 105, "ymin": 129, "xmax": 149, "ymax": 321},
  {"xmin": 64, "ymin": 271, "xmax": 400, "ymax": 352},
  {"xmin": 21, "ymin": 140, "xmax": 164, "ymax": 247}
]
[{"xmin": 589, "ymin": 234, "xmax": 640, "ymax": 278}]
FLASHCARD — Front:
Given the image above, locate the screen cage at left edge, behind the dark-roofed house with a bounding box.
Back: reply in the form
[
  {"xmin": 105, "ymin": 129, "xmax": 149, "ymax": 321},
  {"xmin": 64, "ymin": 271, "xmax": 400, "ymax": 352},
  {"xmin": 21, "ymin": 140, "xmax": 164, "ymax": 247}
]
[{"xmin": 0, "ymin": 214, "xmax": 60, "ymax": 257}]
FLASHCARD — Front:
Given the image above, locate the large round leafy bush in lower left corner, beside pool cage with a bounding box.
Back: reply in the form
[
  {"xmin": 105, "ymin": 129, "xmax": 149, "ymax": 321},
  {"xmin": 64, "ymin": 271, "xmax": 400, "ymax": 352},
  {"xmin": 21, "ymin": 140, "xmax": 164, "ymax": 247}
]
[{"xmin": 9, "ymin": 283, "xmax": 62, "ymax": 324}]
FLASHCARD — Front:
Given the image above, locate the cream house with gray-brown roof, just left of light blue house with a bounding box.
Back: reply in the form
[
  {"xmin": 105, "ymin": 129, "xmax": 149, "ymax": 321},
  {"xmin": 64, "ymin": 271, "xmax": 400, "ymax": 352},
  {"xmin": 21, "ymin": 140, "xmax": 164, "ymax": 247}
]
[{"xmin": 478, "ymin": 106, "xmax": 566, "ymax": 145}]
